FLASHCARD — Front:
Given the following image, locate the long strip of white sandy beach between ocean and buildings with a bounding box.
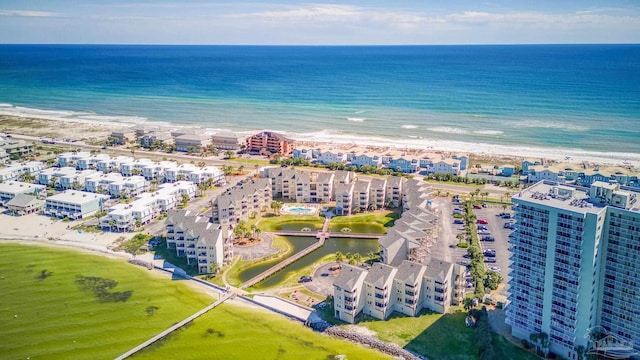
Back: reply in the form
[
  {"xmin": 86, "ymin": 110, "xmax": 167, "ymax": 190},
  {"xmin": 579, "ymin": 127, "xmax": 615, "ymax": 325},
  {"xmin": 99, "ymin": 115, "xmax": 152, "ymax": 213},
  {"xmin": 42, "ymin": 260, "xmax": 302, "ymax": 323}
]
[{"xmin": 0, "ymin": 107, "xmax": 640, "ymax": 168}]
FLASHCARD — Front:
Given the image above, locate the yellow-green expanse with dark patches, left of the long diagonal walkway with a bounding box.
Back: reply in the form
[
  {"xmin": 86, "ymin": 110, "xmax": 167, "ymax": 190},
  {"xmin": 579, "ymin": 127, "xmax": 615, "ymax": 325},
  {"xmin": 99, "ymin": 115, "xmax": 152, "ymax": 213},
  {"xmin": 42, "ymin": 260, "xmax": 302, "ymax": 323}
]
[{"xmin": 0, "ymin": 244, "xmax": 213, "ymax": 359}]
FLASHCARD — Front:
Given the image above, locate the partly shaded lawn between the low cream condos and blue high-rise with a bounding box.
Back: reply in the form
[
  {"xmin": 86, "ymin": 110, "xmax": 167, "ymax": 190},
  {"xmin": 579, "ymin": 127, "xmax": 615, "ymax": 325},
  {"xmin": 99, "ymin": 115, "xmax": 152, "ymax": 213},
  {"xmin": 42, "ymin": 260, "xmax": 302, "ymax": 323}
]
[{"xmin": 358, "ymin": 308, "xmax": 538, "ymax": 360}]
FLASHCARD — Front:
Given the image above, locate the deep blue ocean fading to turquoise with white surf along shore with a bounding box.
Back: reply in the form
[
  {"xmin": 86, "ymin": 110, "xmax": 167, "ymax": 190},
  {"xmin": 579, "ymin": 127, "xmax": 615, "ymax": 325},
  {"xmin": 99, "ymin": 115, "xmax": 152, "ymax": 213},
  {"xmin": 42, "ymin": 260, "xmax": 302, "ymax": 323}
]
[{"xmin": 0, "ymin": 45, "xmax": 640, "ymax": 159}]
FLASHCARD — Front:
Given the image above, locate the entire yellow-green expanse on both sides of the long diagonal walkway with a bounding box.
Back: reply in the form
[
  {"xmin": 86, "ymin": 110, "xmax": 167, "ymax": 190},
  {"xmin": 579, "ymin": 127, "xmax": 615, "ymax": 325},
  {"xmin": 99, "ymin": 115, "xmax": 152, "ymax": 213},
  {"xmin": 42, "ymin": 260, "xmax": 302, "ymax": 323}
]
[{"xmin": 0, "ymin": 244, "xmax": 388, "ymax": 359}]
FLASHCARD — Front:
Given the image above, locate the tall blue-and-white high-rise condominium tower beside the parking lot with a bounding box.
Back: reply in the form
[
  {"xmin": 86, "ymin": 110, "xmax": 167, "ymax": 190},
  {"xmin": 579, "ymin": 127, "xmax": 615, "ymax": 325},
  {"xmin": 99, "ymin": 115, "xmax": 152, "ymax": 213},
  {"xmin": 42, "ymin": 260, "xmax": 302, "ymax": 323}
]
[{"xmin": 507, "ymin": 182, "xmax": 640, "ymax": 359}]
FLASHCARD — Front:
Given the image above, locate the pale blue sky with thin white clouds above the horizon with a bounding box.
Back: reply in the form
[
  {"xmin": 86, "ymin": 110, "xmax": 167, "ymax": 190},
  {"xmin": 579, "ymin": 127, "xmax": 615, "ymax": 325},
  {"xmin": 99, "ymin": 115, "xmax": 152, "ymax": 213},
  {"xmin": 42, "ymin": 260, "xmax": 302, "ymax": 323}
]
[{"xmin": 0, "ymin": 0, "xmax": 640, "ymax": 45}]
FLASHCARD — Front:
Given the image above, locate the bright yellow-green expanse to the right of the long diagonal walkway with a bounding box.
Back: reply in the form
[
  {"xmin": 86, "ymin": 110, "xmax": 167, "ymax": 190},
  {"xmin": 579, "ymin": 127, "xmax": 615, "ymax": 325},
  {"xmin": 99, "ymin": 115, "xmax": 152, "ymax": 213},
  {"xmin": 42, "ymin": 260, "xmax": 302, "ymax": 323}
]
[{"xmin": 134, "ymin": 304, "xmax": 390, "ymax": 360}]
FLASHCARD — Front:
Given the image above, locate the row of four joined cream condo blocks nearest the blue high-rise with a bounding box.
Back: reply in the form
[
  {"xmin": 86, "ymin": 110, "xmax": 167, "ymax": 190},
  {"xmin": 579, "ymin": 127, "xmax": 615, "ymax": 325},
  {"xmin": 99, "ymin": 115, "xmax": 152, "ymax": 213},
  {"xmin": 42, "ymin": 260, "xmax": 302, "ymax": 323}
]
[{"xmin": 333, "ymin": 260, "xmax": 464, "ymax": 323}]
